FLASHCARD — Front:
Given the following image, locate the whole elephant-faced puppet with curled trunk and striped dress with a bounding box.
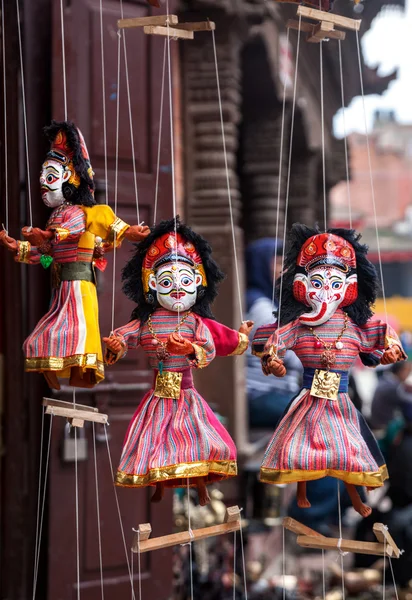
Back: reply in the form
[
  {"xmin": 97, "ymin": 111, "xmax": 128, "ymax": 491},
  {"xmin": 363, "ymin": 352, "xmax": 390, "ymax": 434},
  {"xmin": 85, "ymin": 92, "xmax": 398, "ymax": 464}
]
[{"xmin": 252, "ymin": 224, "xmax": 406, "ymax": 516}]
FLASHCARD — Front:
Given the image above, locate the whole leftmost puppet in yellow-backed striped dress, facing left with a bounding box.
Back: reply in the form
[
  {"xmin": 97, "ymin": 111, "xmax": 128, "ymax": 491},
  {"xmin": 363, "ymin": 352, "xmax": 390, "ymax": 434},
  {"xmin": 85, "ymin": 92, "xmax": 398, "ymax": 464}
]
[{"xmin": 0, "ymin": 121, "xmax": 149, "ymax": 389}]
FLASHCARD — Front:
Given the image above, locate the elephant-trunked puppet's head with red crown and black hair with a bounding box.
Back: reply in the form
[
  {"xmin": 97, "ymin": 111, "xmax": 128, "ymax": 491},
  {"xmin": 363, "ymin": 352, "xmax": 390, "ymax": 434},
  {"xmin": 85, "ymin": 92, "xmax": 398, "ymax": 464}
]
[{"xmin": 277, "ymin": 224, "xmax": 378, "ymax": 326}]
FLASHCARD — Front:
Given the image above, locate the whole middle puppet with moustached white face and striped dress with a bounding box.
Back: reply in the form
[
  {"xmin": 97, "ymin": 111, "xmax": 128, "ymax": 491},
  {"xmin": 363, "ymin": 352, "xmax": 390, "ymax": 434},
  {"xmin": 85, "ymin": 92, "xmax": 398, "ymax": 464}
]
[{"xmin": 103, "ymin": 218, "xmax": 253, "ymax": 505}]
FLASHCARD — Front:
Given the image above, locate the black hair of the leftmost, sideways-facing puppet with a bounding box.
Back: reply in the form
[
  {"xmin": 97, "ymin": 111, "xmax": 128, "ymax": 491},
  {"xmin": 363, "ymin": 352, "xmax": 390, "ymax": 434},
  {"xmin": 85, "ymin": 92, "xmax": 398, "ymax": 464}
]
[{"xmin": 44, "ymin": 121, "xmax": 96, "ymax": 206}]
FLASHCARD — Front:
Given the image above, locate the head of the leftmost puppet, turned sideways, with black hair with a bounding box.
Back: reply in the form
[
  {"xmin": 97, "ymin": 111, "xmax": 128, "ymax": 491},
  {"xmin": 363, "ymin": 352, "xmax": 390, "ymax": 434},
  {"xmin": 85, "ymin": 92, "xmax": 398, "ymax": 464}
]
[{"xmin": 40, "ymin": 121, "xmax": 96, "ymax": 208}]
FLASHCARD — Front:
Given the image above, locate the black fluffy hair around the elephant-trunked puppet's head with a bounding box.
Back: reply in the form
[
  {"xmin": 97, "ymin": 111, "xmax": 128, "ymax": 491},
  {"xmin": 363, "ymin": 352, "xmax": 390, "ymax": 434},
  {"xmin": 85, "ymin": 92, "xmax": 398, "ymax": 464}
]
[{"xmin": 276, "ymin": 223, "xmax": 379, "ymax": 325}]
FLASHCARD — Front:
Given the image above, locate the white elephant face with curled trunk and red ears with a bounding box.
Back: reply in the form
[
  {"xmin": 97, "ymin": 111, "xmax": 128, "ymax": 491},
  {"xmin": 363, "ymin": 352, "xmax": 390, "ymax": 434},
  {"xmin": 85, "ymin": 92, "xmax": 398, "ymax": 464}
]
[{"xmin": 293, "ymin": 266, "xmax": 357, "ymax": 326}]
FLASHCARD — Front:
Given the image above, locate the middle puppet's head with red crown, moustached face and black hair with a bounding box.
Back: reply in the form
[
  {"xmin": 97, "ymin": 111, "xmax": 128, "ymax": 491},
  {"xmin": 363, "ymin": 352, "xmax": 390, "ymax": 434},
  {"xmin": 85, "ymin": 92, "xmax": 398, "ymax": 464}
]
[{"xmin": 123, "ymin": 217, "xmax": 223, "ymax": 322}]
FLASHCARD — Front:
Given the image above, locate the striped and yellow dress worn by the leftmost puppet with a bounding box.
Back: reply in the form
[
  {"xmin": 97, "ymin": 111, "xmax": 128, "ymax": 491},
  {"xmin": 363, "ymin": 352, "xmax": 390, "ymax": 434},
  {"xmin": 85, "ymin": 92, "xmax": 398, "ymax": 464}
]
[{"xmin": 23, "ymin": 204, "xmax": 128, "ymax": 383}]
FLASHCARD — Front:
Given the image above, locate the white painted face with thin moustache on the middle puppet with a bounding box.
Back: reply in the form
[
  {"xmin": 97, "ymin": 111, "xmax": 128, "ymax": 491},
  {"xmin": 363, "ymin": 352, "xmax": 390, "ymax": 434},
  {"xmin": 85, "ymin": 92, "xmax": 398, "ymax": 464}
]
[{"xmin": 149, "ymin": 262, "xmax": 202, "ymax": 312}]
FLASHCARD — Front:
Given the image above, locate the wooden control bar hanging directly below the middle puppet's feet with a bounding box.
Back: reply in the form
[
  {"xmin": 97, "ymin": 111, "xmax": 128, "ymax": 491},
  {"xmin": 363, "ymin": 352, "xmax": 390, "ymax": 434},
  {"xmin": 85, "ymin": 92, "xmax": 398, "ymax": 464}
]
[{"xmin": 132, "ymin": 506, "xmax": 240, "ymax": 554}]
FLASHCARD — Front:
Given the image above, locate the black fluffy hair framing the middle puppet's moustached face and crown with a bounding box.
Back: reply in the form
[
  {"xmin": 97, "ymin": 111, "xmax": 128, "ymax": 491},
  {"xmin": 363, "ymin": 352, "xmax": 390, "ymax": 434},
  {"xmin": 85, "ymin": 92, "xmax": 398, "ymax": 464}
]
[{"xmin": 122, "ymin": 216, "xmax": 224, "ymax": 323}]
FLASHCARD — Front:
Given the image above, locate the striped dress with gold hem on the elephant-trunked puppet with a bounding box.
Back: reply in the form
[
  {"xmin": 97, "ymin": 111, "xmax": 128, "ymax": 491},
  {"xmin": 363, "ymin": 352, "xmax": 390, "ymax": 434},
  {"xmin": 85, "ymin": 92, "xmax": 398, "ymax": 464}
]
[{"xmin": 260, "ymin": 310, "xmax": 400, "ymax": 488}]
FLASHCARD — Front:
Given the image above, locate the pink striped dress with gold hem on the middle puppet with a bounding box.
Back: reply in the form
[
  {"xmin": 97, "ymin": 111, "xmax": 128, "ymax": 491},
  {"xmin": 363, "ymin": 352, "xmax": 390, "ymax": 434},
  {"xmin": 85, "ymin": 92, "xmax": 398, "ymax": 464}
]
[{"xmin": 114, "ymin": 308, "xmax": 238, "ymax": 487}]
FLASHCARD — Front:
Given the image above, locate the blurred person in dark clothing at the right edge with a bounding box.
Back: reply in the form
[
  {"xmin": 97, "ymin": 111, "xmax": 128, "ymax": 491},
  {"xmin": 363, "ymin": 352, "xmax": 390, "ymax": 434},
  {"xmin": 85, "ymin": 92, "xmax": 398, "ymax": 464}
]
[{"xmin": 370, "ymin": 360, "xmax": 412, "ymax": 430}]
